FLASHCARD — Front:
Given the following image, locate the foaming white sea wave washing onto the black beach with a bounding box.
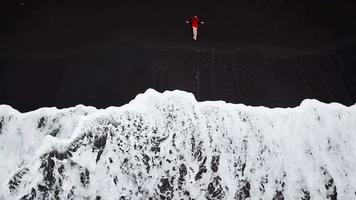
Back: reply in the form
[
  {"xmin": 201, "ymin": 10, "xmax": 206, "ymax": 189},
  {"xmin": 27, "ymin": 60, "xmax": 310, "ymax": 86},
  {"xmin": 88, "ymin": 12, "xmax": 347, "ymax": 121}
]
[{"xmin": 0, "ymin": 90, "xmax": 356, "ymax": 199}]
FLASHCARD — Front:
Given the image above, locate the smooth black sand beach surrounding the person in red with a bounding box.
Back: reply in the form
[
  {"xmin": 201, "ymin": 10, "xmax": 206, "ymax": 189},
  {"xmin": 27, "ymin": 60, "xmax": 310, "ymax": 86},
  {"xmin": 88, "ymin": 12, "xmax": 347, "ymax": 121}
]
[{"xmin": 0, "ymin": 0, "xmax": 356, "ymax": 111}]
